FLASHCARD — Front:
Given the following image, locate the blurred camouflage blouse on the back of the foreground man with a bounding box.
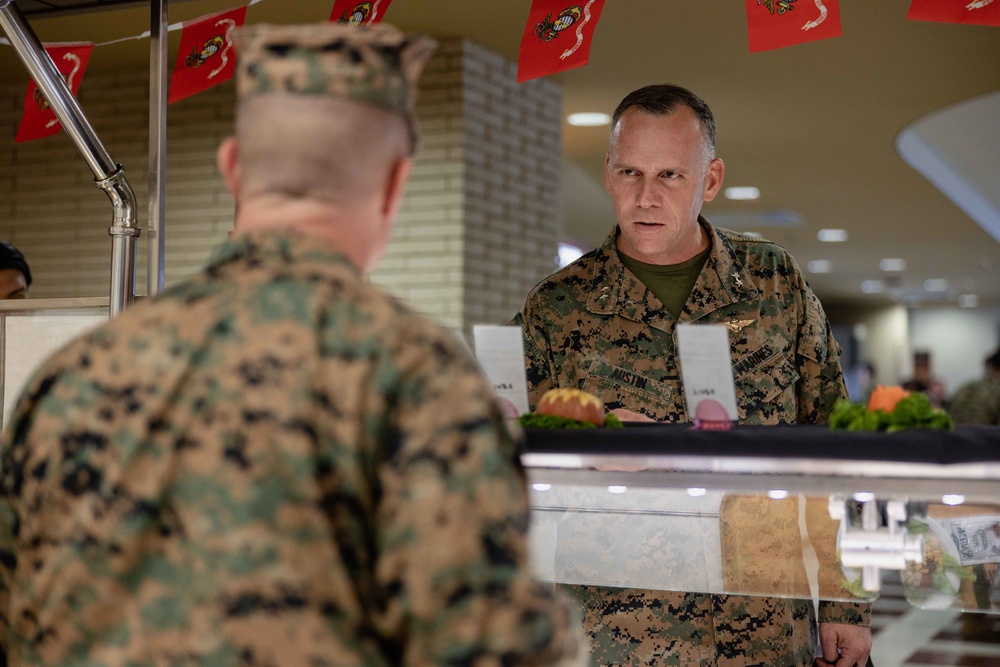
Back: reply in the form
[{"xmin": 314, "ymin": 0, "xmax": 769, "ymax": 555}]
[{"xmin": 0, "ymin": 233, "xmax": 586, "ymax": 667}]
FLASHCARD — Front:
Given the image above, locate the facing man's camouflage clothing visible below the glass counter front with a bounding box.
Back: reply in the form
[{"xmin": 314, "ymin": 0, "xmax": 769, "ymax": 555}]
[{"xmin": 560, "ymin": 585, "xmax": 817, "ymax": 667}]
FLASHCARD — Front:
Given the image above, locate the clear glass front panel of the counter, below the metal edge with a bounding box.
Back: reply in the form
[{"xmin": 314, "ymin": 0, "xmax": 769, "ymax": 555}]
[{"xmin": 529, "ymin": 469, "xmax": 1000, "ymax": 614}]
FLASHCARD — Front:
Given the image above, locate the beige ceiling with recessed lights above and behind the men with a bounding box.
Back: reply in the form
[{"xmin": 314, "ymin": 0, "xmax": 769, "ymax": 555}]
[{"xmin": 3, "ymin": 0, "xmax": 1000, "ymax": 306}]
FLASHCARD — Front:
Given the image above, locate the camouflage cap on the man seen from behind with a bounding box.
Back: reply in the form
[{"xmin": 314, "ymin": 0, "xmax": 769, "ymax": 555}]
[{"xmin": 233, "ymin": 22, "xmax": 437, "ymax": 153}]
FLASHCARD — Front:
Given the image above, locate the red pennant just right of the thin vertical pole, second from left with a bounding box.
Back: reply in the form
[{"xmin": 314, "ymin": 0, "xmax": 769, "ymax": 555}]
[{"xmin": 167, "ymin": 7, "xmax": 247, "ymax": 104}]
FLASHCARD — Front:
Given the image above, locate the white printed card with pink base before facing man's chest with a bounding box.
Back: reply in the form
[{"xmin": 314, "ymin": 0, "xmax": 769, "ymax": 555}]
[{"xmin": 676, "ymin": 324, "xmax": 739, "ymax": 422}]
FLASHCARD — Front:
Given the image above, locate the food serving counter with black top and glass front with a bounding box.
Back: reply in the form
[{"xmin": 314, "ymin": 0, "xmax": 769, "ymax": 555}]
[{"xmin": 522, "ymin": 424, "xmax": 1000, "ymax": 615}]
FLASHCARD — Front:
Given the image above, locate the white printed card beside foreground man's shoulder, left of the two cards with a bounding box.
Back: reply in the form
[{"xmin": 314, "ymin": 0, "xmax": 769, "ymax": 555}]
[{"xmin": 472, "ymin": 324, "xmax": 528, "ymax": 417}]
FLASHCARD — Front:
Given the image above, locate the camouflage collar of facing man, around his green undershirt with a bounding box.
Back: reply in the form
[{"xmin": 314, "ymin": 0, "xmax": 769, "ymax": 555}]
[{"xmin": 587, "ymin": 217, "xmax": 759, "ymax": 331}]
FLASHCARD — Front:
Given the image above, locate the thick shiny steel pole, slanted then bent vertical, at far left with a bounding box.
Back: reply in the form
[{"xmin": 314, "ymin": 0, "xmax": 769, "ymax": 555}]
[{"xmin": 0, "ymin": 0, "xmax": 140, "ymax": 316}]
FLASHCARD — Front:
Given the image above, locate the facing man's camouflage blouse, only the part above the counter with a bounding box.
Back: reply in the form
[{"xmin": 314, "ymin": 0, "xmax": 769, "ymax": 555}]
[{"xmin": 515, "ymin": 220, "xmax": 847, "ymax": 424}]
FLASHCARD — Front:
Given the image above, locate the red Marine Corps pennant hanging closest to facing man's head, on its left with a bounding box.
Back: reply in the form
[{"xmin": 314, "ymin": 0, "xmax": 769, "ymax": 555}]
[{"xmin": 517, "ymin": 0, "xmax": 604, "ymax": 83}]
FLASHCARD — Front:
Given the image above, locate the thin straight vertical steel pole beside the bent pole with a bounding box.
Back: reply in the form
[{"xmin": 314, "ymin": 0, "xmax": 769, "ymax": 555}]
[{"xmin": 146, "ymin": 0, "xmax": 168, "ymax": 296}]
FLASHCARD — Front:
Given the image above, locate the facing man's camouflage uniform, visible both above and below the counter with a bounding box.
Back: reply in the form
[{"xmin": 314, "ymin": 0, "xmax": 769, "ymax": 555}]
[{"xmin": 514, "ymin": 220, "xmax": 868, "ymax": 667}]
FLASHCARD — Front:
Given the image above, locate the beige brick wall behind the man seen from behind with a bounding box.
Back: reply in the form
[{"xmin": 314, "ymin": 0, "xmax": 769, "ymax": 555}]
[{"xmin": 0, "ymin": 40, "xmax": 562, "ymax": 331}]
